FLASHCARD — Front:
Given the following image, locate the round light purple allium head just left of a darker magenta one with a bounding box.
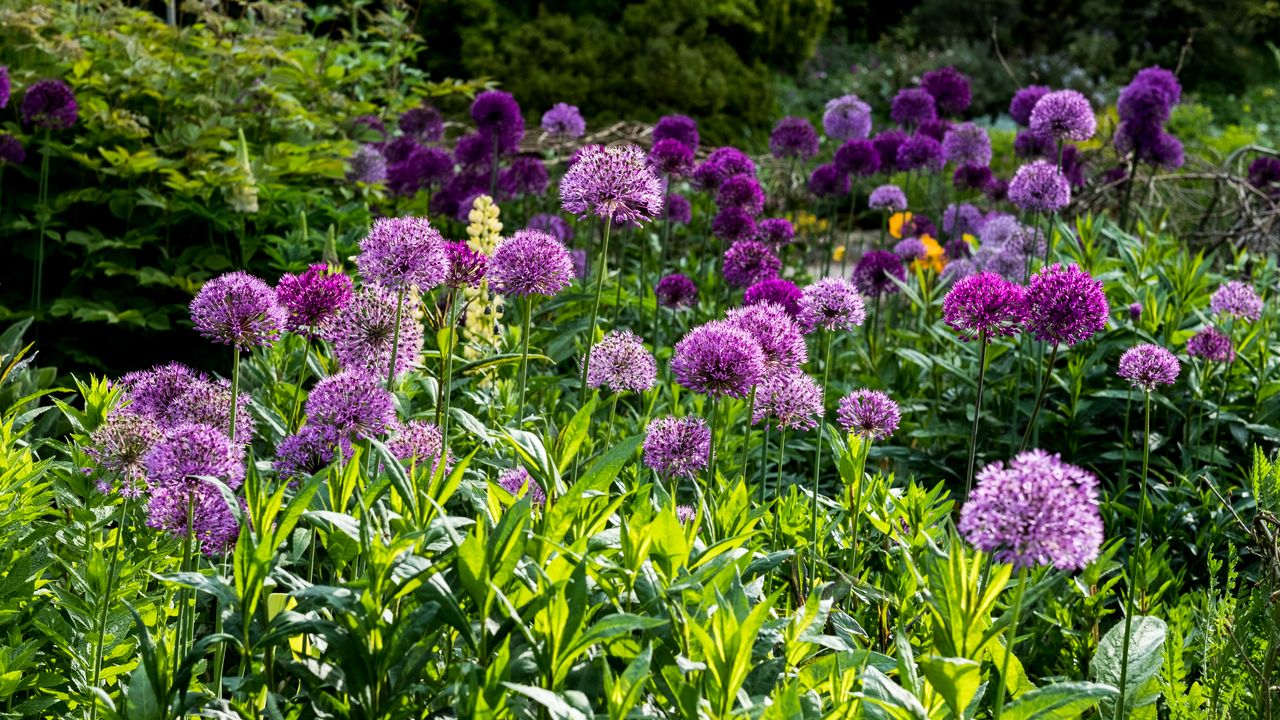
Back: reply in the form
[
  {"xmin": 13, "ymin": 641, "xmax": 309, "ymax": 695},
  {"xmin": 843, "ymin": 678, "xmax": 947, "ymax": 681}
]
[{"xmin": 191, "ymin": 270, "xmax": 288, "ymax": 350}]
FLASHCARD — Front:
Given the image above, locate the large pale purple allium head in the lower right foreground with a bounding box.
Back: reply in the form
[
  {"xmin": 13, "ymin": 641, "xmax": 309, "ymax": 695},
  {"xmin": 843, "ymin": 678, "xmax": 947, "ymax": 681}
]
[{"xmin": 960, "ymin": 450, "xmax": 1103, "ymax": 570}]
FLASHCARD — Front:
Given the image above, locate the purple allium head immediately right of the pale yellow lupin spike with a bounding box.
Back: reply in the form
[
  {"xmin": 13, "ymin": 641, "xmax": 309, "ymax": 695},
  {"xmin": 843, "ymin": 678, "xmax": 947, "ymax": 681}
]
[{"xmin": 488, "ymin": 229, "xmax": 573, "ymax": 297}]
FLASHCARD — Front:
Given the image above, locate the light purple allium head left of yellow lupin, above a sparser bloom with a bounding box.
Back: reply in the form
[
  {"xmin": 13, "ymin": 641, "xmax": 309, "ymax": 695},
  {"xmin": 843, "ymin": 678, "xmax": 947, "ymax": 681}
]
[{"xmin": 356, "ymin": 217, "xmax": 449, "ymax": 292}]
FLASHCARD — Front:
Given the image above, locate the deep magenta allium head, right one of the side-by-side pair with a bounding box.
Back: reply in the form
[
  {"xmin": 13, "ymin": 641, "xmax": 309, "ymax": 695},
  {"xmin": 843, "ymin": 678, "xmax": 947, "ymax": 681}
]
[{"xmin": 1027, "ymin": 263, "xmax": 1108, "ymax": 346}]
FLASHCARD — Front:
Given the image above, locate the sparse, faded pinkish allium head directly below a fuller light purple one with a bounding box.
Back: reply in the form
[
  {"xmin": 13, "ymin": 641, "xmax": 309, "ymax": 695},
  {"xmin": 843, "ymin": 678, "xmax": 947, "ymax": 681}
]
[{"xmin": 321, "ymin": 286, "xmax": 422, "ymax": 378}]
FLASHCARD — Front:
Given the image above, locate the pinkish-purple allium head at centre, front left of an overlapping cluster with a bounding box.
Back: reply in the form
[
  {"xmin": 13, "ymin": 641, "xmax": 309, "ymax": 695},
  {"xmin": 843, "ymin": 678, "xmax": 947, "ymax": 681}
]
[{"xmin": 671, "ymin": 320, "xmax": 765, "ymax": 398}]
